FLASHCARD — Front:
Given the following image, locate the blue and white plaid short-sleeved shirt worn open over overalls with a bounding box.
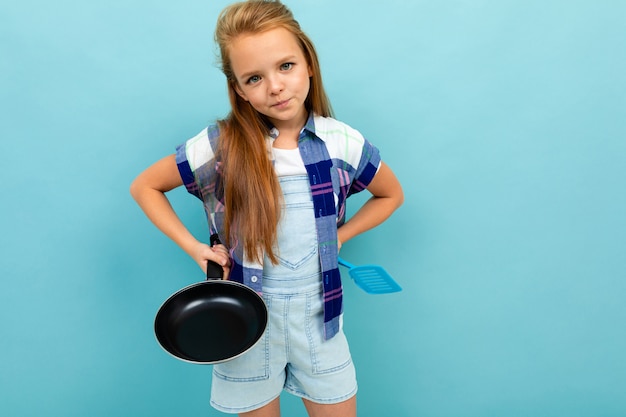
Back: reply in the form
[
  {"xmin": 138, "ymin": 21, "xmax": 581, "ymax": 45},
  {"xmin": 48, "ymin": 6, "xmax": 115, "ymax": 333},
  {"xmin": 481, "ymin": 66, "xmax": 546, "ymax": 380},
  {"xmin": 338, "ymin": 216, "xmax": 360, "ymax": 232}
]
[{"xmin": 176, "ymin": 115, "xmax": 380, "ymax": 339}]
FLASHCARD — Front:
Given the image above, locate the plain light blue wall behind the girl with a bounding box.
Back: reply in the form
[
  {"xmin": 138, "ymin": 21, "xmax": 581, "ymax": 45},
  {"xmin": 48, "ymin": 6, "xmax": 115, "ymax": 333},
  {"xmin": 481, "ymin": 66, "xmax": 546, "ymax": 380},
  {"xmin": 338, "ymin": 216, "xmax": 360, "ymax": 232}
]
[{"xmin": 0, "ymin": 0, "xmax": 626, "ymax": 417}]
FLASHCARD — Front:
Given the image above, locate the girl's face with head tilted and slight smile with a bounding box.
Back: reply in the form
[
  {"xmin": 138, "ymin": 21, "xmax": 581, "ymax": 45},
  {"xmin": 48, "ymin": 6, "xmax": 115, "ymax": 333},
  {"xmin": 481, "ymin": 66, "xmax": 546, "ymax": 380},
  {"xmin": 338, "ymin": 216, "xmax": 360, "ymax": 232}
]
[{"xmin": 229, "ymin": 27, "xmax": 313, "ymax": 131}]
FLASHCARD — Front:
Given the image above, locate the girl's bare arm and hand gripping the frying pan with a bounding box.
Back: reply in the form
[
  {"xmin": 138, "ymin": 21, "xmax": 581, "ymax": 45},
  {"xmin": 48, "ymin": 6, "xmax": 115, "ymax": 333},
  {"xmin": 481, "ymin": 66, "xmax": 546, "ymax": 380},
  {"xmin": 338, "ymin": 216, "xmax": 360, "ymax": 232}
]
[{"xmin": 130, "ymin": 155, "xmax": 230, "ymax": 279}]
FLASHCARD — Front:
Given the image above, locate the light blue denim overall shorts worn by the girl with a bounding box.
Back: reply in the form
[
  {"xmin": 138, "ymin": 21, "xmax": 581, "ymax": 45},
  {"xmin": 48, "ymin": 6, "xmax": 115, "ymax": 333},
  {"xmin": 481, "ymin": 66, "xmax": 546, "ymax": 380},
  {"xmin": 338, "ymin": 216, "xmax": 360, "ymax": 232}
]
[{"xmin": 211, "ymin": 176, "xmax": 357, "ymax": 413}]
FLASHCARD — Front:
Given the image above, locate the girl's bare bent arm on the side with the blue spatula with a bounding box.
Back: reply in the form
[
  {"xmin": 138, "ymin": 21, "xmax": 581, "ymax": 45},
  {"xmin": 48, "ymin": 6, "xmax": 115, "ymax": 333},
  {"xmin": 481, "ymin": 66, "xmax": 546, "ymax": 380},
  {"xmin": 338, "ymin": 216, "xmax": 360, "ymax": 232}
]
[{"xmin": 337, "ymin": 162, "xmax": 404, "ymax": 249}]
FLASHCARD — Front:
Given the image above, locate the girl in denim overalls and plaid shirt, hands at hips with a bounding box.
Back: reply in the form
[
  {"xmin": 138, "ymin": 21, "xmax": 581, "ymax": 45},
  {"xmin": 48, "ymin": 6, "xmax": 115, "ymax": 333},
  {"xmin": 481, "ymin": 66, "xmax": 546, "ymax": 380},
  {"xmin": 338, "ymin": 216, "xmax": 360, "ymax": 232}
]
[{"xmin": 131, "ymin": 0, "xmax": 403, "ymax": 417}]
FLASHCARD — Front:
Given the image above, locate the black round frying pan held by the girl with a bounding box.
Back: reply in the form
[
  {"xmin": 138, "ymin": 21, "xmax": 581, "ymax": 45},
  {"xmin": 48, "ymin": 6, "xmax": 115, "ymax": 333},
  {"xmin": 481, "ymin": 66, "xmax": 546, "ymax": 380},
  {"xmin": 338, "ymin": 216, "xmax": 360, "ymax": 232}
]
[{"xmin": 154, "ymin": 236, "xmax": 268, "ymax": 364}]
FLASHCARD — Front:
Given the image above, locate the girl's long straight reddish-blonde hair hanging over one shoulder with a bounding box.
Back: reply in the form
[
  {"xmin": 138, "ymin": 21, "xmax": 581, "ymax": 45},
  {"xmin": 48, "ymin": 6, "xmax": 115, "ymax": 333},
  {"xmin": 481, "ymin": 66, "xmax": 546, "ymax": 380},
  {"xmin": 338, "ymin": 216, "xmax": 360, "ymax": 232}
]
[{"xmin": 215, "ymin": 0, "xmax": 332, "ymax": 264}]
